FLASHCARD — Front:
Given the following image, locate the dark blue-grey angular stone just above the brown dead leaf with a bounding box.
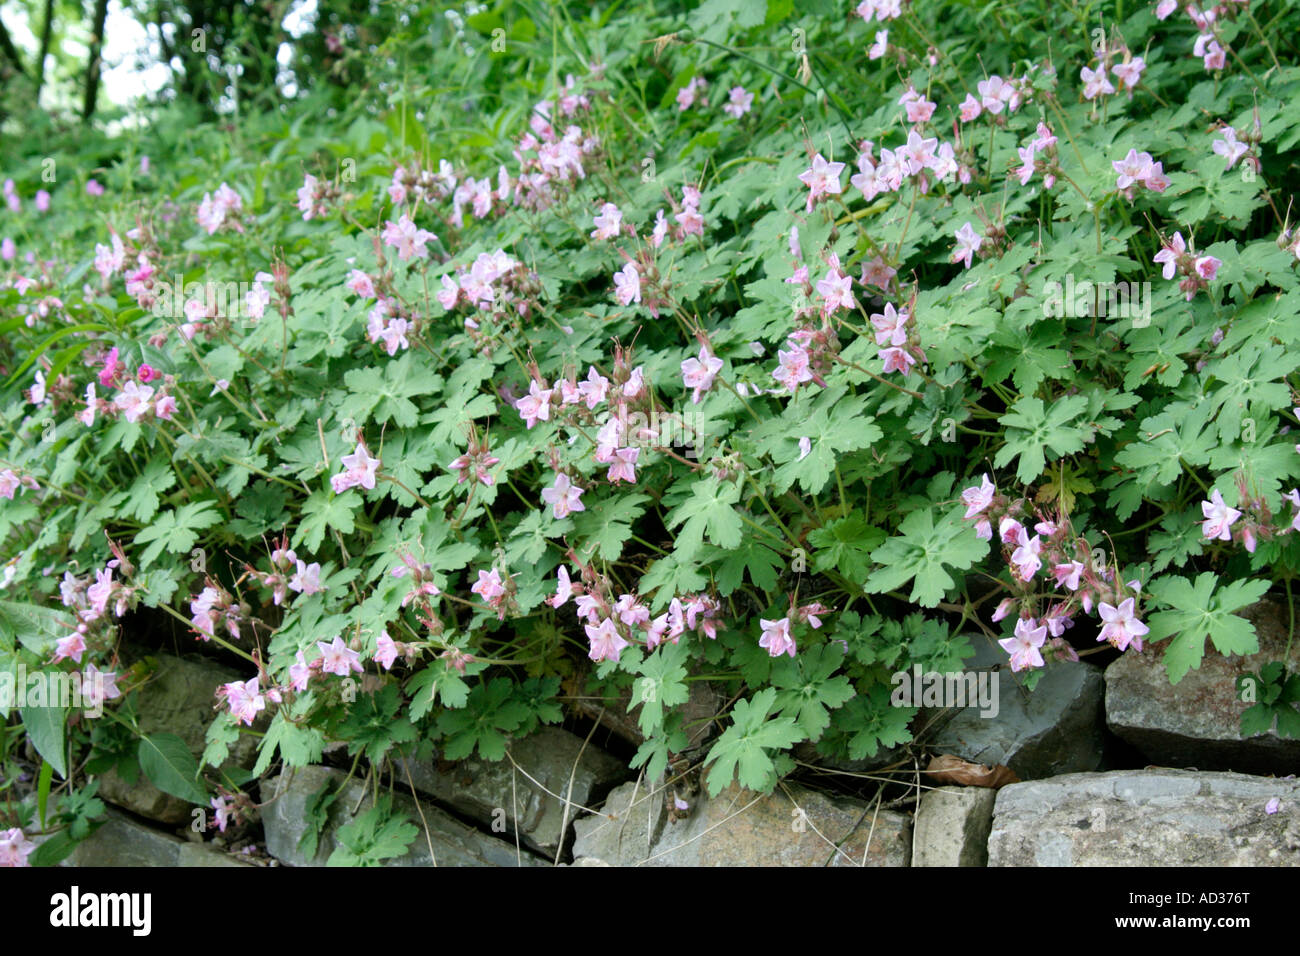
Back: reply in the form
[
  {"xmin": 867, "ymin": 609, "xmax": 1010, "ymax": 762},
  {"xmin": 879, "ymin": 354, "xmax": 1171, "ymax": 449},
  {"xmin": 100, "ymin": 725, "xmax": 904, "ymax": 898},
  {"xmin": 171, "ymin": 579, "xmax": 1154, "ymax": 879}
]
[{"xmin": 930, "ymin": 639, "xmax": 1105, "ymax": 780}]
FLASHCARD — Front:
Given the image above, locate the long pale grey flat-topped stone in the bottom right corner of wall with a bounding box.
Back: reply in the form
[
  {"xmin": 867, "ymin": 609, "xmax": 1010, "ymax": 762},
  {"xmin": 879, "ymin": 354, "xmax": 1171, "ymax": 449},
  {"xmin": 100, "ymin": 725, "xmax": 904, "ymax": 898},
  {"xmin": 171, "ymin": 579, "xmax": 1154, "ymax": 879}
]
[{"xmin": 988, "ymin": 770, "xmax": 1300, "ymax": 866}]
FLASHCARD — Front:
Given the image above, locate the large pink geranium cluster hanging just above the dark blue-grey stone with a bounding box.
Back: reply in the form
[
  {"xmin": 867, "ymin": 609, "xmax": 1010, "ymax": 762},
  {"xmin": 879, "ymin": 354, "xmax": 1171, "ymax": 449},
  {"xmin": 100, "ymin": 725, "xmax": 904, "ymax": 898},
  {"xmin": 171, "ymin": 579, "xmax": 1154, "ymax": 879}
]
[{"xmin": 962, "ymin": 475, "xmax": 1149, "ymax": 671}]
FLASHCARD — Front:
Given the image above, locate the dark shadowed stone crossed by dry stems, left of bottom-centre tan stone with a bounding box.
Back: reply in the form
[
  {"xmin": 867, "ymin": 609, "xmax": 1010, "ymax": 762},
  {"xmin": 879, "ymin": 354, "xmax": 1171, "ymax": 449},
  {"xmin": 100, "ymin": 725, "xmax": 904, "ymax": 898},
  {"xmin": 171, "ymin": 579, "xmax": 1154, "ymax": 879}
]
[{"xmin": 398, "ymin": 727, "xmax": 628, "ymax": 857}]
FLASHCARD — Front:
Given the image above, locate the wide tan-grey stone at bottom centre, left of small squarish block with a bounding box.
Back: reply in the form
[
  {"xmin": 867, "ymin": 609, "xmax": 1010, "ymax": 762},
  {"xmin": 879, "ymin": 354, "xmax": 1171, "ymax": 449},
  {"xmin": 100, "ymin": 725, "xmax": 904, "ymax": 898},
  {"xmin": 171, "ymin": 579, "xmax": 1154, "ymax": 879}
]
[{"xmin": 573, "ymin": 783, "xmax": 911, "ymax": 866}]
